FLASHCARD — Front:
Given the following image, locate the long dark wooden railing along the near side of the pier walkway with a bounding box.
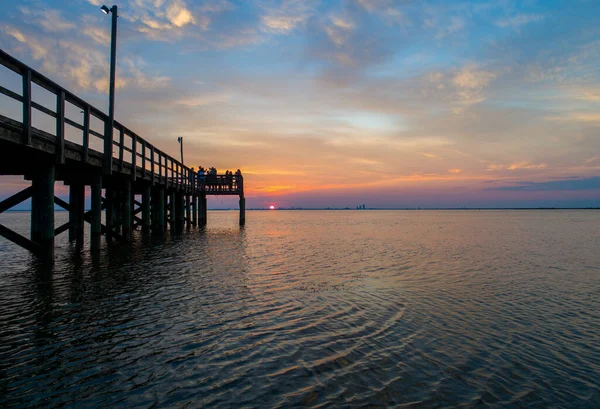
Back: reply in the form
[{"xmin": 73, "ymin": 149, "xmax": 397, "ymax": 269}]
[{"xmin": 0, "ymin": 50, "xmax": 226, "ymax": 190}]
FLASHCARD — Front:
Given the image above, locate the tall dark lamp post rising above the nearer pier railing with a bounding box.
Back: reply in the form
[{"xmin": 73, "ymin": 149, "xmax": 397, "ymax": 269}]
[{"xmin": 100, "ymin": 5, "xmax": 118, "ymax": 174}]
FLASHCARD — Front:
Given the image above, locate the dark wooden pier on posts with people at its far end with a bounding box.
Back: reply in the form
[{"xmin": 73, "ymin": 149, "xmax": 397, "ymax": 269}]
[{"xmin": 0, "ymin": 50, "xmax": 246, "ymax": 260}]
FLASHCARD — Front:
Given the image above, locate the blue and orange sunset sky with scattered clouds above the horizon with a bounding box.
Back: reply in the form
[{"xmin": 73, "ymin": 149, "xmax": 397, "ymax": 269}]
[{"xmin": 0, "ymin": 0, "xmax": 600, "ymax": 208}]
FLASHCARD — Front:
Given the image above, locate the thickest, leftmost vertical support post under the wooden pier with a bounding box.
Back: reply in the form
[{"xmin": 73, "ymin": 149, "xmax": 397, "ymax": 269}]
[{"xmin": 31, "ymin": 166, "xmax": 55, "ymax": 261}]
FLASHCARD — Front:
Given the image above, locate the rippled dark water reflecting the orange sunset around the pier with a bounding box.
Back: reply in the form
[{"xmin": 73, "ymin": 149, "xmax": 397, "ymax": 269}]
[{"xmin": 0, "ymin": 211, "xmax": 600, "ymax": 408}]
